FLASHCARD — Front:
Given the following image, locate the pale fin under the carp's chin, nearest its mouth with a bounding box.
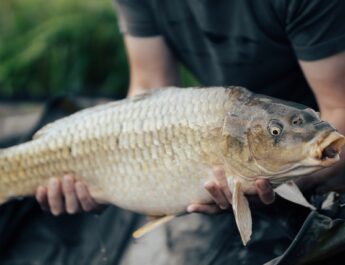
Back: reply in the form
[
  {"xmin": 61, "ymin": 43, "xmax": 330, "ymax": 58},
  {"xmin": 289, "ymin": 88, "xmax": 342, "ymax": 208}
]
[{"xmin": 274, "ymin": 181, "xmax": 316, "ymax": 210}]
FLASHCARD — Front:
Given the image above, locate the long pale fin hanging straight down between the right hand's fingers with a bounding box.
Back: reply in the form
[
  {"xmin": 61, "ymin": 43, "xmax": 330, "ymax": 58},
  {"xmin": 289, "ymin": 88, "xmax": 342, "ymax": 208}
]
[{"xmin": 232, "ymin": 180, "xmax": 252, "ymax": 246}]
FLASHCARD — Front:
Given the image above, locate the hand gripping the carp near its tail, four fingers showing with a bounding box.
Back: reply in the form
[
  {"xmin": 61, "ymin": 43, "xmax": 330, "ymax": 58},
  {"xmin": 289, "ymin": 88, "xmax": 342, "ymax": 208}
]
[{"xmin": 36, "ymin": 175, "xmax": 101, "ymax": 215}]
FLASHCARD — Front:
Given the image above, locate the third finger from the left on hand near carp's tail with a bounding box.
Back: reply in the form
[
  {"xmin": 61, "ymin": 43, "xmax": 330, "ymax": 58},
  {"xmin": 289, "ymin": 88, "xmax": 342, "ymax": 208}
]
[{"xmin": 62, "ymin": 175, "xmax": 80, "ymax": 214}]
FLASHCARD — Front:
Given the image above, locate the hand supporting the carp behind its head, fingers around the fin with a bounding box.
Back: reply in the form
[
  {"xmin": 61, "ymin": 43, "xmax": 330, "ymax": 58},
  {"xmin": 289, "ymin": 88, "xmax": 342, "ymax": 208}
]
[{"xmin": 187, "ymin": 168, "xmax": 274, "ymax": 214}]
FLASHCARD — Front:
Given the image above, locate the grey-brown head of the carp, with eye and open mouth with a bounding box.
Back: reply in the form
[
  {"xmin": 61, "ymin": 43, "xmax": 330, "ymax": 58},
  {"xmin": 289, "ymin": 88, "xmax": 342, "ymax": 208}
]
[{"xmin": 226, "ymin": 89, "xmax": 345, "ymax": 178}]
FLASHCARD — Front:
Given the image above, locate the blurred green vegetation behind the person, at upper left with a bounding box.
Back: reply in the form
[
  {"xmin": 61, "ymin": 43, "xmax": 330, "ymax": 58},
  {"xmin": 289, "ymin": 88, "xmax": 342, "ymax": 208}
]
[{"xmin": 0, "ymin": 0, "xmax": 195, "ymax": 100}]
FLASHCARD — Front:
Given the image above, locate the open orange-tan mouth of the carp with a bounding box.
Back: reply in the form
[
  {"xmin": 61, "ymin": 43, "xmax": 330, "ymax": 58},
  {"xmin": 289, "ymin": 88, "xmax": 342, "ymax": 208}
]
[{"xmin": 314, "ymin": 131, "xmax": 345, "ymax": 167}]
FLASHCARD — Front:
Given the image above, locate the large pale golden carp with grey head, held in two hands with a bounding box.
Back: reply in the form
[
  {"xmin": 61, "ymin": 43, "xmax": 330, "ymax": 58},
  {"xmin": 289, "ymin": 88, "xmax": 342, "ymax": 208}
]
[{"xmin": 0, "ymin": 87, "xmax": 345, "ymax": 244}]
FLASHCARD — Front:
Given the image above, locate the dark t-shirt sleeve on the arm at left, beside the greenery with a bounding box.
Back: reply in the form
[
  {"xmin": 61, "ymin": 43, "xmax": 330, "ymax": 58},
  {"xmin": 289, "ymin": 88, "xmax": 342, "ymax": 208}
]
[{"xmin": 114, "ymin": 0, "xmax": 160, "ymax": 37}]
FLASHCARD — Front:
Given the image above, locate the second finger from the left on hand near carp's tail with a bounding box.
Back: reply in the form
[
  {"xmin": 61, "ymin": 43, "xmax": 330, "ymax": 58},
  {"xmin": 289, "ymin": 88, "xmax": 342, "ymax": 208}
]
[{"xmin": 48, "ymin": 178, "xmax": 65, "ymax": 215}]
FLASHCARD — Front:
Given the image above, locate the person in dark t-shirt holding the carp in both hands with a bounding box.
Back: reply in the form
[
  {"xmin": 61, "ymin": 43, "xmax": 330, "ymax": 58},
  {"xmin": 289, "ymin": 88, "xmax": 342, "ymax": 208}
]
[{"xmin": 2, "ymin": 0, "xmax": 345, "ymax": 264}]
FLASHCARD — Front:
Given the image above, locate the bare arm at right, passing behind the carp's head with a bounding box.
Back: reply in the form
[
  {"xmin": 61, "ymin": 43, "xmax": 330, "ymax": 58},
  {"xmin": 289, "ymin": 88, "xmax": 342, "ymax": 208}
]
[{"xmin": 299, "ymin": 52, "xmax": 345, "ymax": 191}]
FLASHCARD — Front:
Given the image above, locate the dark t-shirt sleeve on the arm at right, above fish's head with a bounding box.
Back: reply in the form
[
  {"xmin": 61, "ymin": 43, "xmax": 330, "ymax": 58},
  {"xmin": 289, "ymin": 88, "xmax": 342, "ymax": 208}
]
[{"xmin": 285, "ymin": 0, "xmax": 345, "ymax": 61}]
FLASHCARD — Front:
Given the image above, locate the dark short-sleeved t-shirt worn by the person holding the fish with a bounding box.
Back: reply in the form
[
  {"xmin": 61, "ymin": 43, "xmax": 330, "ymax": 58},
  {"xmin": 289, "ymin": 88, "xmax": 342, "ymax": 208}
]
[{"xmin": 116, "ymin": 0, "xmax": 345, "ymax": 108}]
